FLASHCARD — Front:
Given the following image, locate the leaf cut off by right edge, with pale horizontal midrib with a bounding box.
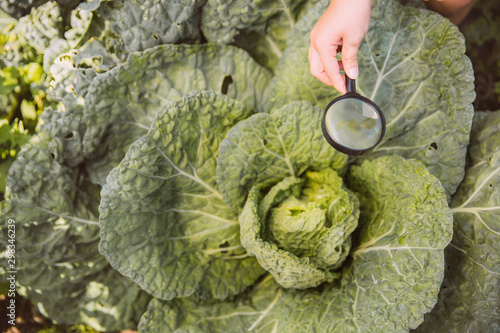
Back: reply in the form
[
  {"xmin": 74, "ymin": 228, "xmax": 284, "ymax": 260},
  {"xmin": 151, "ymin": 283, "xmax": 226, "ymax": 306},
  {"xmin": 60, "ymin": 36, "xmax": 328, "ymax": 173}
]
[{"xmin": 419, "ymin": 112, "xmax": 500, "ymax": 332}]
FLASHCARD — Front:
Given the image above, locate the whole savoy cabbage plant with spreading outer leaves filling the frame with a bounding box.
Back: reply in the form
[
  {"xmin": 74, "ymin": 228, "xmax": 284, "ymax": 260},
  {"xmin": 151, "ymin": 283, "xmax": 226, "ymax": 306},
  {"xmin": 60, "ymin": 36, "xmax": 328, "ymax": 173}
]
[{"xmin": 0, "ymin": 0, "xmax": 500, "ymax": 332}]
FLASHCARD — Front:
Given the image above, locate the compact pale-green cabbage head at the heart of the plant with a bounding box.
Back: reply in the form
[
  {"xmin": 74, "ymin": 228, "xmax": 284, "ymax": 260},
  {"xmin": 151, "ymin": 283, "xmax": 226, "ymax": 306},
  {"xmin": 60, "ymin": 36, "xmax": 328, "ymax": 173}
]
[{"xmin": 240, "ymin": 169, "xmax": 359, "ymax": 289}]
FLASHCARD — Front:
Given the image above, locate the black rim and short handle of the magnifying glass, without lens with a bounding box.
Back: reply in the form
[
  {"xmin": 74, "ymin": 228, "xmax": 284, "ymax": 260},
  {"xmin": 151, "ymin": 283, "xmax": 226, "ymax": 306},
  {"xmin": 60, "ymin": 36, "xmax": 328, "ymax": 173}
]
[{"xmin": 321, "ymin": 75, "xmax": 385, "ymax": 156}]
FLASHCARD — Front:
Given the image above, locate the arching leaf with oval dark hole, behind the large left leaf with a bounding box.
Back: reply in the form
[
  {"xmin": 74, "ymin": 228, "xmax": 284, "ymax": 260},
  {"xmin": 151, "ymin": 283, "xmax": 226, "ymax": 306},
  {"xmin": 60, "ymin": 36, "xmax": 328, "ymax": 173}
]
[{"xmin": 83, "ymin": 44, "xmax": 271, "ymax": 184}]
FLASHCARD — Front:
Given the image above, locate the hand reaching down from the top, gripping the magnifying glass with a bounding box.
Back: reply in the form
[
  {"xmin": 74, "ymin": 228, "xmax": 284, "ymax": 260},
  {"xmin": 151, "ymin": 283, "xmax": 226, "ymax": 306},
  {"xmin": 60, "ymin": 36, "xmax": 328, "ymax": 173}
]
[{"xmin": 309, "ymin": 0, "xmax": 372, "ymax": 94}]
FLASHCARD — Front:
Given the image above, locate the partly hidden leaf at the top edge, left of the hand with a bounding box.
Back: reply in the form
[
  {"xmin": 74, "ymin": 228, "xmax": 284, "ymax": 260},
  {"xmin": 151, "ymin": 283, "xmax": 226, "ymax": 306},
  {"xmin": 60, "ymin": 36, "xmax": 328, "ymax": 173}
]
[{"xmin": 201, "ymin": 0, "xmax": 317, "ymax": 69}]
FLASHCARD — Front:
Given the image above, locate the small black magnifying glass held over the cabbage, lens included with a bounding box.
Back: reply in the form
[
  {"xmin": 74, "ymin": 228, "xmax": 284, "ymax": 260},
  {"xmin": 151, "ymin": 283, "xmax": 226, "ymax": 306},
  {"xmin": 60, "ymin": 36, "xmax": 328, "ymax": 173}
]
[{"xmin": 321, "ymin": 75, "xmax": 385, "ymax": 156}]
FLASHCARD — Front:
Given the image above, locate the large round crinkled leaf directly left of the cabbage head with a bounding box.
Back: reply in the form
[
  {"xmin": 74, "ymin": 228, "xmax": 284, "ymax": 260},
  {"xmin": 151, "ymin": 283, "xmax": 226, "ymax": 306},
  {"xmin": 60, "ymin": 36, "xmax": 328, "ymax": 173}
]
[{"xmin": 99, "ymin": 92, "xmax": 263, "ymax": 299}]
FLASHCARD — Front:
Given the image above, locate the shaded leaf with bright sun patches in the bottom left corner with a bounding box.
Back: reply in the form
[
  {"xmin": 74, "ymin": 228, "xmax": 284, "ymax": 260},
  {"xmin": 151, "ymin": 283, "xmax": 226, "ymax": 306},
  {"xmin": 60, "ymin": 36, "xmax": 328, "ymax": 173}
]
[{"xmin": 18, "ymin": 266, "xmax": 151, "ymax": 332}]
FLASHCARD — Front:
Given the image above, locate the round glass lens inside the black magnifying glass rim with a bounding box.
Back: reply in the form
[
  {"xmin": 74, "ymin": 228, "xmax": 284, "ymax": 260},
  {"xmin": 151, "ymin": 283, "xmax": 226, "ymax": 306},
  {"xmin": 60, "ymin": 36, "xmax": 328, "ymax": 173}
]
[{"xmin": 324, "ymin": 98, "xmax": 383, "ymax": 150}]
